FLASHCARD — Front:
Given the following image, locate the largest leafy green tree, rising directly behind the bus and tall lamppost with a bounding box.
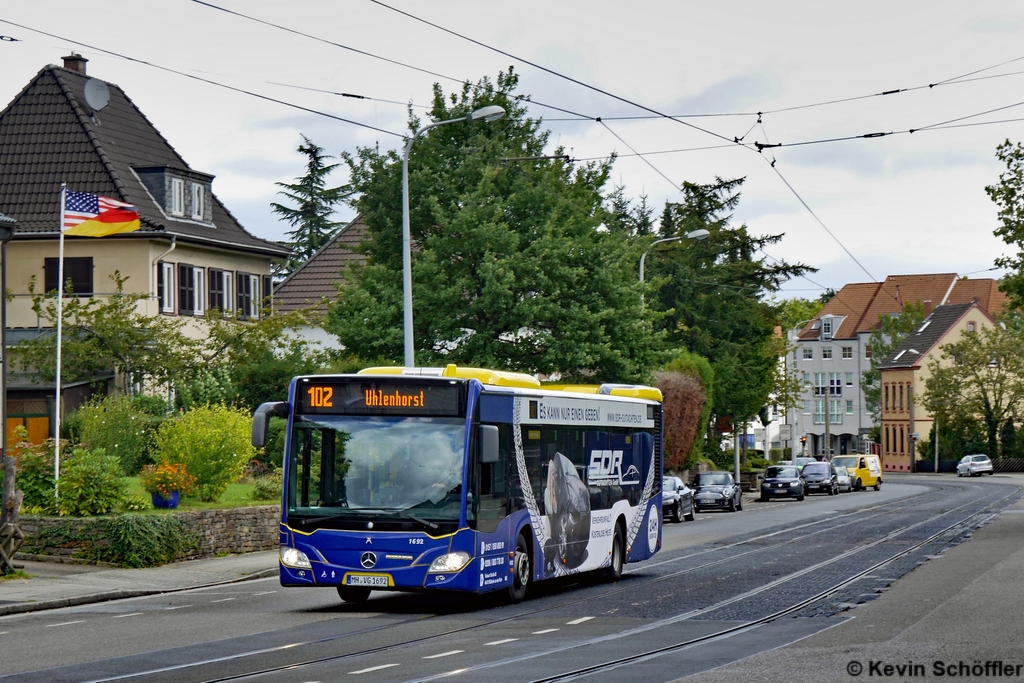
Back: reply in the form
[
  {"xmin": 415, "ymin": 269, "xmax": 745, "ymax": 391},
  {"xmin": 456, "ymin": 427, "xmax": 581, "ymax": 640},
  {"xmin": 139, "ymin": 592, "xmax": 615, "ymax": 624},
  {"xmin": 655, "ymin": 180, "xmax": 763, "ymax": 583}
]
[{"xmin": 326, "ymin": 70, "xmax": 659, "ymax": 381}]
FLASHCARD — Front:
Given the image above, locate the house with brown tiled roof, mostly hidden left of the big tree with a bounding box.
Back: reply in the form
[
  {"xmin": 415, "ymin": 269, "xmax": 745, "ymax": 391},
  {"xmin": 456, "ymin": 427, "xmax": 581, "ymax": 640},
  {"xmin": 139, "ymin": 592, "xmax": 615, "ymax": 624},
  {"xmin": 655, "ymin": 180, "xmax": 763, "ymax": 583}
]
[{"xmin": 273, "ymin": 215, "xmax": 370, "ymax": 347}]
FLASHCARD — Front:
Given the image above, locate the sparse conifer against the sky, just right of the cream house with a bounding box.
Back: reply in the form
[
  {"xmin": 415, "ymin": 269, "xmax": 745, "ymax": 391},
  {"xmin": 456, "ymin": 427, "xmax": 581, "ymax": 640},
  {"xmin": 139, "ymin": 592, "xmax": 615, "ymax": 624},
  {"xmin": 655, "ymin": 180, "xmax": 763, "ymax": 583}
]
[{"xmin": 270, "ymin": 135, "xmax": 350, "ymax": 276}]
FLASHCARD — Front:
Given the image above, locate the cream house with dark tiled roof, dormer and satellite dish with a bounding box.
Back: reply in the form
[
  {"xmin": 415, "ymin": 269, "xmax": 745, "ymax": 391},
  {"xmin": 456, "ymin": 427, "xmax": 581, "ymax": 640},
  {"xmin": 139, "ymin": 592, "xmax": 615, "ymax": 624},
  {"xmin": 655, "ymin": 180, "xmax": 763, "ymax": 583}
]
[{"xmin": 0, "ymin": 54, "xmax": 289, "ymax": 438}]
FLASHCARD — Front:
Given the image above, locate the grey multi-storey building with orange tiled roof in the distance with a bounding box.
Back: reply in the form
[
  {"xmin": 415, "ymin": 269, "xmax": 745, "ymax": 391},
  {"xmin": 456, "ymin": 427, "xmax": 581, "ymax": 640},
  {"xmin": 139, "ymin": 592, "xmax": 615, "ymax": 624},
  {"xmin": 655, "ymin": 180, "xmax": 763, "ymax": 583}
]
[{"xmin": 786, "ymin": 272, "xmax": 1007, "ymax": 460}]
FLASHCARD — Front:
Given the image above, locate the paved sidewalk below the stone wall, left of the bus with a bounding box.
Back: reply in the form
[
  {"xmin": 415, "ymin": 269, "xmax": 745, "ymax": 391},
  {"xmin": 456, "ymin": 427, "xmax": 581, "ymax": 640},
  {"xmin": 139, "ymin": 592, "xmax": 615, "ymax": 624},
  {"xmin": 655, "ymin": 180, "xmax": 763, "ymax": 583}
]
[{"xmin": 0, "ymin": 550, "xmax": 278, "ymax": 616}]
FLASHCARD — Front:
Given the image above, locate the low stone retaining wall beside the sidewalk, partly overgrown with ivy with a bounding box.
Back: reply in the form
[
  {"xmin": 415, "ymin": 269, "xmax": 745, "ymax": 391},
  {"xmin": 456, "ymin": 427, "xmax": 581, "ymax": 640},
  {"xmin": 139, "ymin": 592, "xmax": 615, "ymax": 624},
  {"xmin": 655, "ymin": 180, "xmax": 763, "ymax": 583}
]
[{"xmin": 18, "ymin": 505, "xmax": 281, "ymax": 562}]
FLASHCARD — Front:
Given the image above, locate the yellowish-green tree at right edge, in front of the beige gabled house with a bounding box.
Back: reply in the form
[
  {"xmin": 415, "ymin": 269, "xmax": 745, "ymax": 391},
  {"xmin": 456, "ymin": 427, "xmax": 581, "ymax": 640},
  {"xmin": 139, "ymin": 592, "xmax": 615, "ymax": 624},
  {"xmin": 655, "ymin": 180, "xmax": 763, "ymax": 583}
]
[{"xmin": 925, "ymin": 318, "xmax": 1024, "ymax": 458}]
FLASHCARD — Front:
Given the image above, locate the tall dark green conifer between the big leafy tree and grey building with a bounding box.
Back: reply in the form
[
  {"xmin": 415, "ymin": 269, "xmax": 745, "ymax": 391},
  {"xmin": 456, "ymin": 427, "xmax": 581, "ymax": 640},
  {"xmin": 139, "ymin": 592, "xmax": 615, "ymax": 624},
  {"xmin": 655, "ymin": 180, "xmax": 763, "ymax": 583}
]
[{"xmin": 647, "ymin": 178, "xmax": 814, "ymax": 430}]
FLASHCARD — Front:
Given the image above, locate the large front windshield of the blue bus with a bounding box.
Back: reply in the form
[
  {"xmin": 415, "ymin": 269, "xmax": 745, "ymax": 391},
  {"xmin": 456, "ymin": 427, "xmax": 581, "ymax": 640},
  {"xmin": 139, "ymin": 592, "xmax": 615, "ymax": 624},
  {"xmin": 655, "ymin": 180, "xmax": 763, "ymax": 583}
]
[{"xmin": 287, "ymin": 415, "xmax": 466, "ymax": 521}]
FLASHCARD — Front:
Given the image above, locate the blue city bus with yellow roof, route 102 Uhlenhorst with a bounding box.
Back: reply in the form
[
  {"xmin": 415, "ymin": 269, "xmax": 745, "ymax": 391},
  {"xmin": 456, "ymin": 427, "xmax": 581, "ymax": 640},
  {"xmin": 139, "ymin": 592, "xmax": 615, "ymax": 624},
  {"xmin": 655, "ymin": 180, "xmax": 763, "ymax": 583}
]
[{"xmin": 253, "ymin": 366, "xmax": 663, "ymax": 602}]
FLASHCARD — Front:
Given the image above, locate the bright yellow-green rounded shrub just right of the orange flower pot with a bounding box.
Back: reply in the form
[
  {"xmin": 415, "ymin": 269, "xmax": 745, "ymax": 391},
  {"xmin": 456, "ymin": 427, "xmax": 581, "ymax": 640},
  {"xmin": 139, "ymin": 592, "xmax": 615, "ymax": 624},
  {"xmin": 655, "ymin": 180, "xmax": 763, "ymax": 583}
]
[{"xmin": 155, "ymin": 405, "xmax": 256, "ymax": 502}]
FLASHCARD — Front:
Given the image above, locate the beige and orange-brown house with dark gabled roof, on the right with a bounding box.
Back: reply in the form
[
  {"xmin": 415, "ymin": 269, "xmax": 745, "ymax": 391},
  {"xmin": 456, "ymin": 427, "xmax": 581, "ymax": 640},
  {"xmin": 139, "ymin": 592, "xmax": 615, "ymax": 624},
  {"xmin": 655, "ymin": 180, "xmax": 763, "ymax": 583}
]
[{"xmin": 879, "ymin": 301, "xmax": 995, "ymax": 472}]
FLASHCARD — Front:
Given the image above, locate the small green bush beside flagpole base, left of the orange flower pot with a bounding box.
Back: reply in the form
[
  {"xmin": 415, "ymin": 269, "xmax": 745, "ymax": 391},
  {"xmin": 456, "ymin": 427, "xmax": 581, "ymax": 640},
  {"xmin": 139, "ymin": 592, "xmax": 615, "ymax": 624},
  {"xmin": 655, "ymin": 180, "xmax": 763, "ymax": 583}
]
[{"xmin": 57, "ymin": 449, "xmax": 127, "ymax": 517}]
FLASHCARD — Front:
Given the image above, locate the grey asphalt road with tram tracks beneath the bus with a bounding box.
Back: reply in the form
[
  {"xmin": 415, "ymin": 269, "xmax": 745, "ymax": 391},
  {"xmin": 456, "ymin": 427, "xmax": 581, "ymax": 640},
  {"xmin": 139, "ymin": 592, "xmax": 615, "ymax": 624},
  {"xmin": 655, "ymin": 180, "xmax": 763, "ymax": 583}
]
[{"xmin": 0, "ymin": 476, "xmax": 1021, "ymax": 683}]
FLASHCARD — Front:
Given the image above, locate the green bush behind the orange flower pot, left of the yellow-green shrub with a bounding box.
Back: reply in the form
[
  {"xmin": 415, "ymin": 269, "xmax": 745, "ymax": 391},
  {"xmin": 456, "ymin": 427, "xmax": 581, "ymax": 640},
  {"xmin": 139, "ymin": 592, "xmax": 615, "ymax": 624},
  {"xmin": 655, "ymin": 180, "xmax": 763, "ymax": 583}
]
[{"xmin": 70, "ymin": 396, "xmax": 163, "ymax": 475}]
